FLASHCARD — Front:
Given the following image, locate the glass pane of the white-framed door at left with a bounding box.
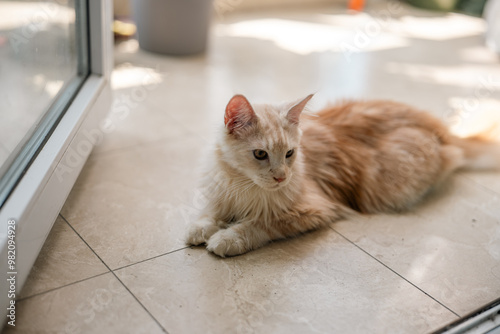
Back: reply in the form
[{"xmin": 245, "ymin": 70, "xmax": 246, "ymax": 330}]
[{"xmin": 0, "ymin": 0, "xmax": 88, "ymax": 206}]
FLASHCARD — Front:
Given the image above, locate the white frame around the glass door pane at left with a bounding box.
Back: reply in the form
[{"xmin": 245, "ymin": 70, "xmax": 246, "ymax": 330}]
[{"xmin": 0, "ymin": 0, "xmax": 113, "ymax": 321}]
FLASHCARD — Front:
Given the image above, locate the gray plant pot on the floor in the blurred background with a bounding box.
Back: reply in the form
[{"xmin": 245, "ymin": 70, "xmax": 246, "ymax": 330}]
[{"xmin": 131, "ymin": 0, "xmax": 213, "ymax": 55}]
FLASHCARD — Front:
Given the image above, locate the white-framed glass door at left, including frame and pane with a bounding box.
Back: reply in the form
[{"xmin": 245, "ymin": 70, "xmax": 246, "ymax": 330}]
[{"xmin": 0, "ymin": 0, "xmax": 113, "ymax": 320}]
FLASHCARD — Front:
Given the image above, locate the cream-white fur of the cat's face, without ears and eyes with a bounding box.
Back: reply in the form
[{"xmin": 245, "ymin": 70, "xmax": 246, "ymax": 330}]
[{"xmin": 221, "ymin": 105, "xmax": 301, "ymax": 191}]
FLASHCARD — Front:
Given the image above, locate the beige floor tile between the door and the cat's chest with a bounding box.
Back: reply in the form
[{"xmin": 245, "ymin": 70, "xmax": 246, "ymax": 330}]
[{"xmin": 61, "ymin": 136, "xmax": 209, "ymax": 269}]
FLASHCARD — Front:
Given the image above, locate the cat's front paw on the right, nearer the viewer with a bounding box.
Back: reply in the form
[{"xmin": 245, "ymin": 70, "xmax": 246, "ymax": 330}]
[{"xmin": 207, "ymin": 228, "xmax": 249, "ymax": 257}]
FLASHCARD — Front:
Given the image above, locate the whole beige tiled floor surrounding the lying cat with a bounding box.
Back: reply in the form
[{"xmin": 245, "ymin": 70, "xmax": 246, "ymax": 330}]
[{"xmin": 5, "ymin": 4, "xmax": 500, "ymax": 333}]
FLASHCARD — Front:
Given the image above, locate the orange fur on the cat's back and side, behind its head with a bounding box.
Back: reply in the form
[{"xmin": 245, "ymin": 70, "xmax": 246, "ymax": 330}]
[{"xmin": 301, "ymin": 101, "xmax": 464, "ymax": 213}]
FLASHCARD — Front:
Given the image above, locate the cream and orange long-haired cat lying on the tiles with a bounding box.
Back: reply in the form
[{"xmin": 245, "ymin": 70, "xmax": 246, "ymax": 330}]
[{"xmin": 186, "ymin": 95, "xmax": 500, "ymax": 257}]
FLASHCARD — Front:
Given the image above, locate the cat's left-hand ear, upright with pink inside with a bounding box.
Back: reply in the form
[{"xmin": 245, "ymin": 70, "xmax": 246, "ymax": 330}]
[{"xmin": 224, "ymin": 95, "xmax": 257, "ymax": 133}]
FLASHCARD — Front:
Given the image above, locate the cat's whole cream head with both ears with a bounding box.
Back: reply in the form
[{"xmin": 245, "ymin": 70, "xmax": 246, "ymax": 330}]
[{"xmin": 220, "ymin": 95, "xmax": 313, "ymax": 191}]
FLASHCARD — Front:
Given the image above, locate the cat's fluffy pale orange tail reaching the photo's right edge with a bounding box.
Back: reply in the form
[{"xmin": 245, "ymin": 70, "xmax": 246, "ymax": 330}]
[{"xmin": 452, "ymin": 134, "xmax": 500, "ymax": 170}]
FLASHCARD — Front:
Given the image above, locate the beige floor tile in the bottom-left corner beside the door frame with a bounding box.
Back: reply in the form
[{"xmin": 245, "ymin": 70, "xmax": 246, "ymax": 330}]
[{"xmin": 3, "ymin": 273, "xmax": 163, "ymax": 334}]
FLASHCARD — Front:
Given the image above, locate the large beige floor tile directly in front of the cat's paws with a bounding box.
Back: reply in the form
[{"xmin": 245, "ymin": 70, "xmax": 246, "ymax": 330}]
[{"xmin": 116, "ymin": 229, "xmax": 456, "ymax": 333}]
